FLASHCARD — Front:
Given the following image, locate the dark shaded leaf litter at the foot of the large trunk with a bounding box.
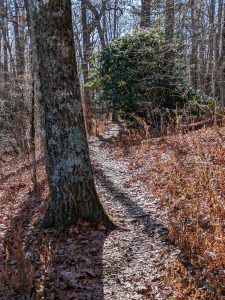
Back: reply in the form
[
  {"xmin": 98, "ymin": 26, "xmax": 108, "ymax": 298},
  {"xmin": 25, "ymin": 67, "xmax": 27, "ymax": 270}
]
[{"xmin": 0, "ymin": 176, "xmax": 110, "ymax": 300}]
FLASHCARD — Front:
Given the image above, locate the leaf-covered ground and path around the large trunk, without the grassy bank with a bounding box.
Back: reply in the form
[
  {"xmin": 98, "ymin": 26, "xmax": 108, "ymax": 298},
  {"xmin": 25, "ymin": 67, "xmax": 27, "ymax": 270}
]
[{"xmin": 0, "ymin": 125, "xmax": 223, "ymax": 300}]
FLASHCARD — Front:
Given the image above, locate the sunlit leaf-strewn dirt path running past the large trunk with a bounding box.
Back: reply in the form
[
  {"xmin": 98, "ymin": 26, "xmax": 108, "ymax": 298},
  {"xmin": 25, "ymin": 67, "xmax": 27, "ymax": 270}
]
[{"xmin": 90, "ymin": 125, "xmax": 178, "ymax": 300}]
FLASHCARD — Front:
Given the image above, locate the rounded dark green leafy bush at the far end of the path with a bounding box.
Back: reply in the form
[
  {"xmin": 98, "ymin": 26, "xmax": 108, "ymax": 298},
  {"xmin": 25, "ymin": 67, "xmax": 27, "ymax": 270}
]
[{"xmin": 92, "ymin": 30, "xmax": 188, "ymax": 123}]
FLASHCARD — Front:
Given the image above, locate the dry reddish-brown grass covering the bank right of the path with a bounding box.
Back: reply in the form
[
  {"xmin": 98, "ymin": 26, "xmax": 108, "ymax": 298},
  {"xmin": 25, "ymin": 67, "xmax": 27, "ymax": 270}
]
[{"xmin": 127, "ymin": 127, "xmax": 225, "ymax": 299}]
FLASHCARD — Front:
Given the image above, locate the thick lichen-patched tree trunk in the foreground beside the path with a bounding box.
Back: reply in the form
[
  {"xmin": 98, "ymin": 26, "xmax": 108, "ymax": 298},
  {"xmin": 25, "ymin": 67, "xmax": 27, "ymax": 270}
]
[{"xmin": 29, "ymin": 0, "xmax": 114, "ymax": 230}]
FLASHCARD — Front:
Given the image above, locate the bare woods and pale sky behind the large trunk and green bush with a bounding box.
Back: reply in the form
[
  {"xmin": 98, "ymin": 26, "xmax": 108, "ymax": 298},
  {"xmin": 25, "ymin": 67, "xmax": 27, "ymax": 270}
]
[{"xmin": 0, "ymin": 0, "xmax": 225, "ymax": 151}]
